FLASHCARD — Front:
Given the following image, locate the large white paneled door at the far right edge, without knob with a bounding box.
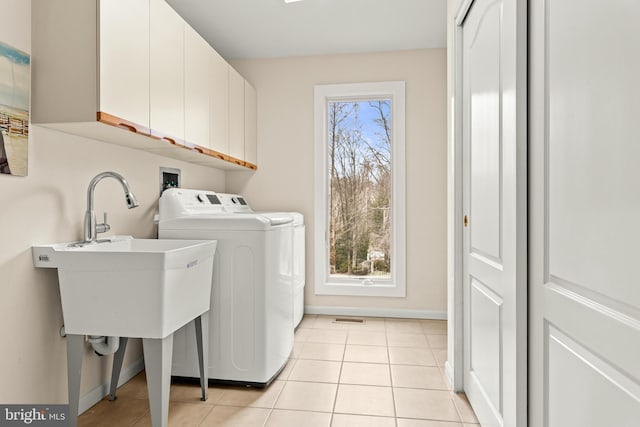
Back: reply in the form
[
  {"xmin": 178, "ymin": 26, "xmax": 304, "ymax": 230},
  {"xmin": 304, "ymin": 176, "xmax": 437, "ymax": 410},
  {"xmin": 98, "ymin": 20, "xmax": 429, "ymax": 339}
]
[{"xmin": 529, "ymin": 0, "xmax": 640, "ymax": 426}]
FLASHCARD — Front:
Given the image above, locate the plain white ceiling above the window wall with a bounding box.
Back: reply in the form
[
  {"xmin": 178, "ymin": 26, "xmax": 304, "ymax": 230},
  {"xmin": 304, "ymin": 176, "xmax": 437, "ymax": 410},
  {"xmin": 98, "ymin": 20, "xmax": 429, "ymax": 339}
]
[{"xmin": 167, "ymin": 0, "xmax": 447, "ymax": 59}]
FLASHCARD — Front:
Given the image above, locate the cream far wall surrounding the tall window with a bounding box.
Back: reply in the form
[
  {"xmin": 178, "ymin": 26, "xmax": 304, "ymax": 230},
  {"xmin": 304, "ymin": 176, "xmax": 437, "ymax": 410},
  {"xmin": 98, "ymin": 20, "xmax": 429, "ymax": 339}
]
[{"xmin": 227, "ymin": 49, "xmax": 447, "ymax": 315}]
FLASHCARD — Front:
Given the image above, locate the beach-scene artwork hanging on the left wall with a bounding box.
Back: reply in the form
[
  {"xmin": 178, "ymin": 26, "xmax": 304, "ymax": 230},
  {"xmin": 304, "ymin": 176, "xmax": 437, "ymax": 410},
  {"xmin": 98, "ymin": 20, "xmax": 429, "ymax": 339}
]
[{"xmin": 0, "ymin": 41, "xmax": 31, "ymax": 176}]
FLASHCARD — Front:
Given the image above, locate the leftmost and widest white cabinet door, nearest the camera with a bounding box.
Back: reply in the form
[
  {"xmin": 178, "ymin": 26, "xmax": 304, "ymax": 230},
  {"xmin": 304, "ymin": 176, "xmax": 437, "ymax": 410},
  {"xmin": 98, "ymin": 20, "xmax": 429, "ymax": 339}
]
[{"xmin": 98, "ymin": 0, "xmax": 149, "ymax": 128}]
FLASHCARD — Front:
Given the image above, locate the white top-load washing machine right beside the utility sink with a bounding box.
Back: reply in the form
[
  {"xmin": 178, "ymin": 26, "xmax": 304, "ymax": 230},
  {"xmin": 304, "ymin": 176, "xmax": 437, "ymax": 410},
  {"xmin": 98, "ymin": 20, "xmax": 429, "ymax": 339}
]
[{"xmin": 158, "ymin": 188, "xmax": 294, "ymax": 387}]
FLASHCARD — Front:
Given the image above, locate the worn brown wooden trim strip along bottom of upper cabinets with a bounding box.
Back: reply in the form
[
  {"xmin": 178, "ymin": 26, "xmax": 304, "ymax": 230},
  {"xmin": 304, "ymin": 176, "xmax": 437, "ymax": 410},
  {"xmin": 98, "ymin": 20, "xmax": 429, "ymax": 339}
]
[{"xmin": 97, "ymin": 111, "xmax": 257, "ymax": 170}]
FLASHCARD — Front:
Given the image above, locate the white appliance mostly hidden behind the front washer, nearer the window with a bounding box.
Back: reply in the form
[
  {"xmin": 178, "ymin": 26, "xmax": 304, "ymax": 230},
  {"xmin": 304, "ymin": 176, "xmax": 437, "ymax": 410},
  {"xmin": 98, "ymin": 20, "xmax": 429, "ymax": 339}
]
[{"xmin": 217, "ymin": 193, "xmax": 305, "ymax": 327}]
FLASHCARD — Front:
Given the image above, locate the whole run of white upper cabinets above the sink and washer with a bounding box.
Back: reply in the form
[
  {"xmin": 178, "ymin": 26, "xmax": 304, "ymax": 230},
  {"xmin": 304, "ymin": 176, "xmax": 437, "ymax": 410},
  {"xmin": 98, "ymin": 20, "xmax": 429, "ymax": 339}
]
[{"xmin": 31, "ymin": 0, "xmax": 256, "ymax": 170}]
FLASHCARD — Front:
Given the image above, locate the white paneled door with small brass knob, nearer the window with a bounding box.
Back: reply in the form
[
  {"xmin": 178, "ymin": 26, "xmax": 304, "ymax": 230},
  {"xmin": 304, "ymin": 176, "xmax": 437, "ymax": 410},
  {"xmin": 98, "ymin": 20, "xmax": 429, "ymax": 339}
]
[{"xmin": 458, "ymin": 0, "xmax": 527, "ymax": 427}]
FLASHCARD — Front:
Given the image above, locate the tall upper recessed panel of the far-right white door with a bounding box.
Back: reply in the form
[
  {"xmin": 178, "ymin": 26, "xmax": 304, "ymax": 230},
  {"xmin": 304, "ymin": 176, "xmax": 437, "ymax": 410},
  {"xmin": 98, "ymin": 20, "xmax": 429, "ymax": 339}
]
[{"xmin": 546, "ymin": 0, "xmax": 640, "ymax": 308}]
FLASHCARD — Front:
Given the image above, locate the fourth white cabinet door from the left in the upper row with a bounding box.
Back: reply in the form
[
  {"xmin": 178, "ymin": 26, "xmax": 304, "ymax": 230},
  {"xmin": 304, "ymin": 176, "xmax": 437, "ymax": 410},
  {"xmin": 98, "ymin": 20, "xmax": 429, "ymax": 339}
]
[{"xmin": 210, "ymin": 51, "xmax": 229, "ymax": 154}]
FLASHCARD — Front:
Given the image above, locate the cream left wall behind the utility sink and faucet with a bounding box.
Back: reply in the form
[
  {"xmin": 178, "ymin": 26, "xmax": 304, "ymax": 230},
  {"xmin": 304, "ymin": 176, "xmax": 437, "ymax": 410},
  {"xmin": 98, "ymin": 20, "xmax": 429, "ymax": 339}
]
[{"xmin": 0, "ymin": 0, "xmax": 225, "ymax": 404}]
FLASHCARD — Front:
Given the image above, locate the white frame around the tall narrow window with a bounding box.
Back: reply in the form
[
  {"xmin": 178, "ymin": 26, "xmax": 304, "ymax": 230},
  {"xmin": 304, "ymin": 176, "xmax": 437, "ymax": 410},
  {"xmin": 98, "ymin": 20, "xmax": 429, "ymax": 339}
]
[{"xmin": 314, "ymin": 81, "xmax": 407, "ymax": 297}]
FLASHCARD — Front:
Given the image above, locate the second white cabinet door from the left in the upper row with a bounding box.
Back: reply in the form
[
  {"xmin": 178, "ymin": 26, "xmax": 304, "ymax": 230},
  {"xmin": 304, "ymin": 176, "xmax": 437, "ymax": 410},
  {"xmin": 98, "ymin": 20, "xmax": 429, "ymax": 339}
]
[{"xmin": 149, "ymin": 0, "xmax": 184, "ymax": 139}]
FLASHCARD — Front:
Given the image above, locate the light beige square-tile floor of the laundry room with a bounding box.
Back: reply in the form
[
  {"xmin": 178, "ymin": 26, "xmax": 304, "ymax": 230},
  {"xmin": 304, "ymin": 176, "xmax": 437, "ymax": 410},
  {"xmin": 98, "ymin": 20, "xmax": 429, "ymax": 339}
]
[{"xmin": 79, "ymin": 315, "xmax": 478, "ymax": 427}]
